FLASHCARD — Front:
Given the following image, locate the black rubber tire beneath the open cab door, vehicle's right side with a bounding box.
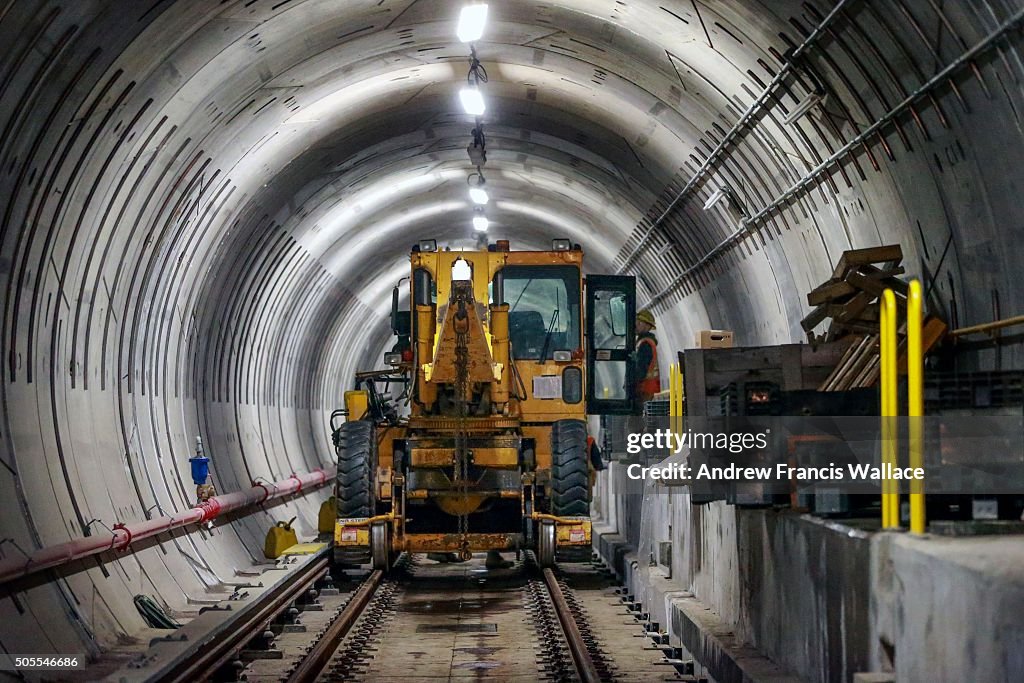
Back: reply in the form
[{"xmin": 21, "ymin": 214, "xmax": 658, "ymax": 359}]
[{"xmin": 551, "ymin": 420, "xmax": 590, "ymax": 517}]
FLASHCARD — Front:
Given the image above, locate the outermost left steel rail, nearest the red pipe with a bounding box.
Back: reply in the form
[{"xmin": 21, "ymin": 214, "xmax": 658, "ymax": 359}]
[{"xmin": 157, "ymin": 549, "xmax": 331, "ymax": 683}]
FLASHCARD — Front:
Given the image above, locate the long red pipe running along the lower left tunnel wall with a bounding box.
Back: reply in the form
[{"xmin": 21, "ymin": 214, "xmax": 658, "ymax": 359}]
[{"xmin": 0, "ymin": 469, "xmax": 329, "ymax": 586}]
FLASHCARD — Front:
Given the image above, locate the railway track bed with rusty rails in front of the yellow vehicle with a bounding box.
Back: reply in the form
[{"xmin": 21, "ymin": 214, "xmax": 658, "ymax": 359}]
[{"xmin": 161, "ymin": 554, "xmax": 695, "ymax": 683}]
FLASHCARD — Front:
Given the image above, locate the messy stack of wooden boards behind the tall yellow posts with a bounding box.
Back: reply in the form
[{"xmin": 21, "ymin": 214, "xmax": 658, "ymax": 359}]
[{"xmin": 800, "ymin": 245, "xmax": 946, "ymax": 391}]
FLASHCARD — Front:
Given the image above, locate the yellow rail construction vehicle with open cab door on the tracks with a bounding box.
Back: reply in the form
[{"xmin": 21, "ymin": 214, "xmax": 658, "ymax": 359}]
[{"xmin": 332, "ymin": 240, "xmax": 636, "ymax": 568}]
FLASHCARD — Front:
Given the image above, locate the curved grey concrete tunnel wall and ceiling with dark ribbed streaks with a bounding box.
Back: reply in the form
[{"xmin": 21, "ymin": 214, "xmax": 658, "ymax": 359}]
[{"xmin": 0, "ymin": 0, "xmax": 1024, "ymax": 667}]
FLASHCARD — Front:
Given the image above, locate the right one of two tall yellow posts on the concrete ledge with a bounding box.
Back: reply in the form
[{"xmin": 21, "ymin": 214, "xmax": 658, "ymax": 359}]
[{"xmin": 906, "ymin": 280, "xmax": 925, "ymax": 533}]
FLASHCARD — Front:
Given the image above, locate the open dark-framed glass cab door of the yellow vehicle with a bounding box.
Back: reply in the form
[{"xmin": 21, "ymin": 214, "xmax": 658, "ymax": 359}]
[{"xmin": 586, "ymin": 275, "xmax": 637, "ymax": 415}]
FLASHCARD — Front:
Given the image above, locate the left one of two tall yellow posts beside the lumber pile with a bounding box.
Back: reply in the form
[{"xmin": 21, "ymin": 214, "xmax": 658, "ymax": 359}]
[{"xmin": 879, "ymin": 289, "xmax": 899, "ymax": 528}]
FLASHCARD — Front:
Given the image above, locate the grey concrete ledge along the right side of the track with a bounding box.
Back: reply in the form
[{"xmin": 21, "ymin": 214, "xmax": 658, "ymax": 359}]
[{"xmin": 594, "ymin": 495, "xmax": 1024, "ymax": 683}]
